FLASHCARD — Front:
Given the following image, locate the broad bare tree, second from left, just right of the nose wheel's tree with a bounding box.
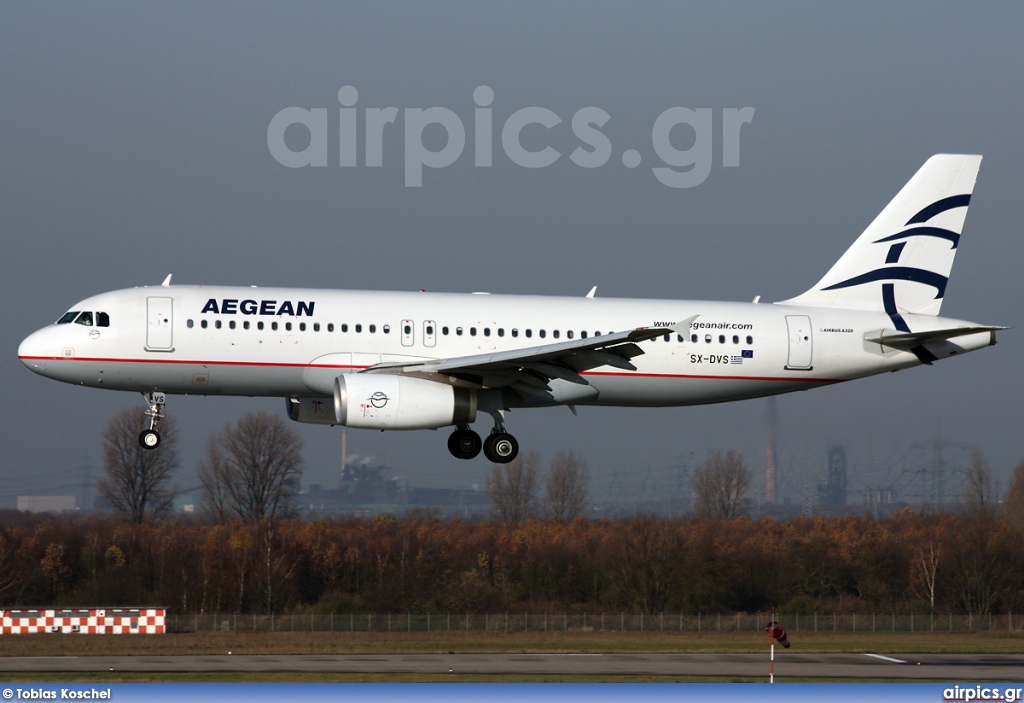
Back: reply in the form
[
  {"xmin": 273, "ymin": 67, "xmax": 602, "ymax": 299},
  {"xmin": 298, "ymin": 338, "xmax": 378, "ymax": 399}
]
[{"xmin": 197, "ymin": 412, "xmax": 302, "ymax": 524}]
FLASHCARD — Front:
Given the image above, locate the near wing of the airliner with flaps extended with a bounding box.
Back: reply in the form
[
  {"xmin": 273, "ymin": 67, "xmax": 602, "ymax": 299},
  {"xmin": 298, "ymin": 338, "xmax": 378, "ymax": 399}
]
[{"xmin": 364, "ymin": 315, "xmax": 697, "ymax": 397}]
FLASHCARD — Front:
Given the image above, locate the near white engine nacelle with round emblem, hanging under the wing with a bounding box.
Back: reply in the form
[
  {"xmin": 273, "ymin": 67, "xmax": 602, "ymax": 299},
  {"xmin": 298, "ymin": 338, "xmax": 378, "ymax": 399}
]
[{"xmin": 334, "ymin": 374, "xmax": 476, "ymax": 430}]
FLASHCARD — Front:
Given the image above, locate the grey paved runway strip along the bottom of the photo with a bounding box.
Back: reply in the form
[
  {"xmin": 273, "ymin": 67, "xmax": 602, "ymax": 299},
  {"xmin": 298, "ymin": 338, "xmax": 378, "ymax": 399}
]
[{"xmin": 0, "ymin": 652, "xmax": 1024, "ymax": 682}]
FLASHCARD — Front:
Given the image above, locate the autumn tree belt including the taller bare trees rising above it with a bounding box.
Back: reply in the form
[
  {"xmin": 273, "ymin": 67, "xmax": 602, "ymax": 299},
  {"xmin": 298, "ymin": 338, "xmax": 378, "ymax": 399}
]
[{"xmin": 0, "ymin": 414, "xmax": 1024, "ymax": 615}]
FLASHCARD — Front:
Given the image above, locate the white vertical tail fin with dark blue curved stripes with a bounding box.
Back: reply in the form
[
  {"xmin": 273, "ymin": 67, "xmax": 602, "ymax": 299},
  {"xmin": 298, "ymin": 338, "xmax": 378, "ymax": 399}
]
[{"xmin": 780, "ymin": 153, "xmax": 981, "ymax": 320}]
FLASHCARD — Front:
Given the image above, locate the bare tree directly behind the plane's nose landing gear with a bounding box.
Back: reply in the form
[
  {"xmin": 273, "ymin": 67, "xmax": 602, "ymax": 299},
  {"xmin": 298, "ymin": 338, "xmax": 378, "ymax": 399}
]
[{"xmin": 97, "ymin": 408, "xmax": 178, "ymax": 524}]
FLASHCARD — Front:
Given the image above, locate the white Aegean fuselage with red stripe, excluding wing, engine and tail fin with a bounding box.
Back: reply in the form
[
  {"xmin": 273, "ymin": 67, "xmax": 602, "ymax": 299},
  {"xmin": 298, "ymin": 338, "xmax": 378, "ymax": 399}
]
[{"xmin": 18, "ymin": 285, "xmax": 993, "ymax": 406}]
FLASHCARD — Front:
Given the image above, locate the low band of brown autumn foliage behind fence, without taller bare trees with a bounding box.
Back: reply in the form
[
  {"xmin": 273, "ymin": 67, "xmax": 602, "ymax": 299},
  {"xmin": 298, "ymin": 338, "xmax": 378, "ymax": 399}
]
[{"xmin": 0, "ymin": 512, "xmax": 1024, "ymax": 614}]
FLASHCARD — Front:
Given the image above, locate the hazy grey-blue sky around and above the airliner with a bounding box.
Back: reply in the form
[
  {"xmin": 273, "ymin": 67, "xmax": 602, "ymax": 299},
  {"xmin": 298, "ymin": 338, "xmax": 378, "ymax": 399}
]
[{"xmin": 0, "ymin": 2, "xmax": 1024, "ymax": 506}]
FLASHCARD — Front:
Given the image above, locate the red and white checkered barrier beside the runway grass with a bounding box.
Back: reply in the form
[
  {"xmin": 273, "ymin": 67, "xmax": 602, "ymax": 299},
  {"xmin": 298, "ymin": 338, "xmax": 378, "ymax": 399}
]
[{"xmin": 0, "ymin": 608, "xmax": 167, "ymax": 634}]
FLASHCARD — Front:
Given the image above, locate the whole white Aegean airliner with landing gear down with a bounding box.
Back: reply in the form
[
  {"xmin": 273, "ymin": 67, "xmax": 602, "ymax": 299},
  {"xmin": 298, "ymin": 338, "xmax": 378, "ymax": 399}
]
[{"xmin": 18, "ymin": 155, "xmax": 1005, "ymax": 463}]
